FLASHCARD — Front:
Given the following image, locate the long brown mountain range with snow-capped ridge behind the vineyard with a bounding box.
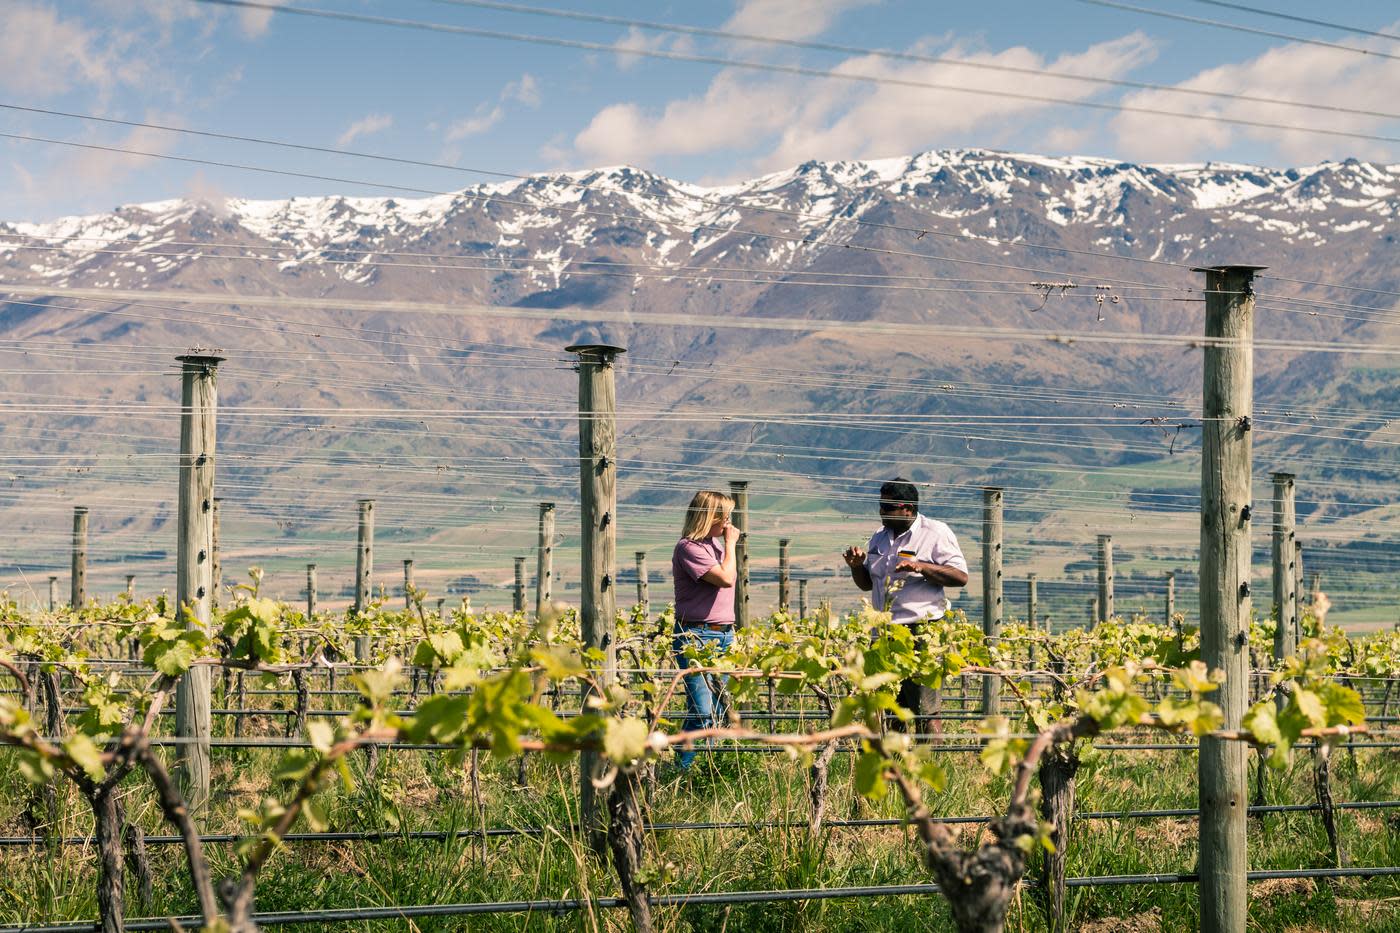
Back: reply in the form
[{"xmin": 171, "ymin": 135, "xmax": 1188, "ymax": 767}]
[{"xmin": 0, "ymin": 150, "xmax": 1400, "ymax": 588}]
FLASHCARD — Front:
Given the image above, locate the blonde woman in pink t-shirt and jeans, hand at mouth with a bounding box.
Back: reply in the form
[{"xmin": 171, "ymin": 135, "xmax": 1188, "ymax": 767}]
[{"xmin": 671, "ymin": 481, "xmax": 739, "ymax": 770}]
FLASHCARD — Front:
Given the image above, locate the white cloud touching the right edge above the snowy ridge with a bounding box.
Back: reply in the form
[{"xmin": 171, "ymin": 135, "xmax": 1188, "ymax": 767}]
[{"xmin": 1112, "ymin": 24, "xmax": 1400, "ymax": 164}]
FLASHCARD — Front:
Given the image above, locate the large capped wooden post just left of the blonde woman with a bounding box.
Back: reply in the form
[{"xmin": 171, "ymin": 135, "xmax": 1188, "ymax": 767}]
[{"xmin": 567, "ymin": 345, "xmax": 624, "ymax": 855}]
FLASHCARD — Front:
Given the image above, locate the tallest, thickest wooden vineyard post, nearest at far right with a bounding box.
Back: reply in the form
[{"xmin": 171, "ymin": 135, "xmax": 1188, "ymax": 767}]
[{"xmin": 1198, "ymin": 266, "xmax": 1257, "ymax": 933}]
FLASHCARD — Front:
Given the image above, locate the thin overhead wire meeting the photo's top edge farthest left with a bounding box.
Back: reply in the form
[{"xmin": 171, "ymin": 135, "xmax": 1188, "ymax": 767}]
[{"xmin": 195, "ymin": 0, "xmax": 1400, "ymax": 143}]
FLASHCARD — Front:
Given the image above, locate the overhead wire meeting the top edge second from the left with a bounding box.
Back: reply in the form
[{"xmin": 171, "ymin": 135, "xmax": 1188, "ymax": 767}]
[{"xmin": 422, "ymin": 0, "xmax": 1400, "ymax": 119}]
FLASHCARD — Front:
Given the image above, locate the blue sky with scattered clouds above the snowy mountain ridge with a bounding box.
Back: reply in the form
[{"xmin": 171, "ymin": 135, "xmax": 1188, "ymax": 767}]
[{"xmin": 0, "ymin": 0, "xmax": 1400, "ymax": 220}]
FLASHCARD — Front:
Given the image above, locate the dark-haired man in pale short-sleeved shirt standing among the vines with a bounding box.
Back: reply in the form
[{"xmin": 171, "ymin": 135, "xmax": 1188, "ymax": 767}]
[{"xmin": 841, "ymin": 478, "xmax": 967, "ymax": 733}]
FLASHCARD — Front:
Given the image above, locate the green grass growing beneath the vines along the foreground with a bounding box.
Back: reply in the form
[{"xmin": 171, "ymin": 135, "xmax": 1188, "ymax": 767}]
[{"xmin": 0, "ymin": 689, "xmax": 1400, "ymax": 933}]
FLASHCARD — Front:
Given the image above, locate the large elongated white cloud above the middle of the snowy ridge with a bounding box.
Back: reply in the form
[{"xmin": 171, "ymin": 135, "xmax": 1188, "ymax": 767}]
[{"xmin": 574, "ymin": 32, "xmax": 1156, "ymax": 174}]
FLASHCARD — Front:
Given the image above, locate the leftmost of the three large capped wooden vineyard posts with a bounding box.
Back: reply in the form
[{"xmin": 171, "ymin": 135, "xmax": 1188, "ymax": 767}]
[{"xmin": 175, "ymin": 353, "xmax": 223, "ymax": 811}]
